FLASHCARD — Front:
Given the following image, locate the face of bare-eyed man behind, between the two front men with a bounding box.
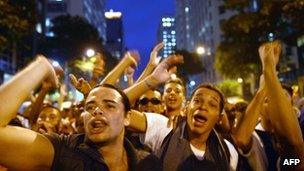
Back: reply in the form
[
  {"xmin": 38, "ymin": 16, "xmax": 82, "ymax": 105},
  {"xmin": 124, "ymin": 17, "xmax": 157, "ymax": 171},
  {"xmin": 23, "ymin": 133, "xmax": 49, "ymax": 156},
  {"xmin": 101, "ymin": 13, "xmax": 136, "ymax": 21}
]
[{"xmin": 163, "ymin": 83, "xmax": 185, "ymax": 109}]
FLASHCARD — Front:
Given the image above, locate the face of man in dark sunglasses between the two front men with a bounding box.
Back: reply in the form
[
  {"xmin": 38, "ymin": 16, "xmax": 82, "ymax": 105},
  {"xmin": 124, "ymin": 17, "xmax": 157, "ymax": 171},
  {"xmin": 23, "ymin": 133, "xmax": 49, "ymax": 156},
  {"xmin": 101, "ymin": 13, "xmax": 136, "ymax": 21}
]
[{"xmin": 138, "ymin": 90, "xmax": 162, "ymax": 113}]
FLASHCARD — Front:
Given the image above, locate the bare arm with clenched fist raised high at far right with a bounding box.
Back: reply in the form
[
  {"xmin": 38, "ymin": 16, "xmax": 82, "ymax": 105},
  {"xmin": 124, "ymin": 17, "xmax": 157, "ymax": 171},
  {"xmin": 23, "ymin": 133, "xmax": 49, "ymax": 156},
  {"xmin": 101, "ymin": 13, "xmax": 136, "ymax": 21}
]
[{"xmin": 259, "ymin": 42, "xmax": 304, "ymax": 155}]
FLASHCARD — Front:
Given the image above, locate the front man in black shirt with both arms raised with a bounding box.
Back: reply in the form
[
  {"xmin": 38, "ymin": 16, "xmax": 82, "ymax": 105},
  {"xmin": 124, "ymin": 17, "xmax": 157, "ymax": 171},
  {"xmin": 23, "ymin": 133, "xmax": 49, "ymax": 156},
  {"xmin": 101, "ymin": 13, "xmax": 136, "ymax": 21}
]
[{"xmin": 0, "ymin": 56, "xmax": 182, "ymax": 170}]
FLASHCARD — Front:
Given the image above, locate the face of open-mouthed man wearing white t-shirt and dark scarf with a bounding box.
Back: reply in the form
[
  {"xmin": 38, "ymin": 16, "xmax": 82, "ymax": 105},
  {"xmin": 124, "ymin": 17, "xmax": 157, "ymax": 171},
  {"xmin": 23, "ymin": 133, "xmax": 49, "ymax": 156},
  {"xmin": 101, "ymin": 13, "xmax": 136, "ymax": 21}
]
[{"xmin": 187, "ymin": 88, "xmax": 221, "ymax": 135}]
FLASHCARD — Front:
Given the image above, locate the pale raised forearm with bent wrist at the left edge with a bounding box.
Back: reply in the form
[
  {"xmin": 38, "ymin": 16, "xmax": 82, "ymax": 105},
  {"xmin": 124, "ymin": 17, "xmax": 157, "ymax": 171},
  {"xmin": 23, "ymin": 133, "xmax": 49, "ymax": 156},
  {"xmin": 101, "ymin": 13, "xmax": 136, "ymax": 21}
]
[{"xmin": 0, "ymin": 57, "xmax": 58, "ymax": 126}]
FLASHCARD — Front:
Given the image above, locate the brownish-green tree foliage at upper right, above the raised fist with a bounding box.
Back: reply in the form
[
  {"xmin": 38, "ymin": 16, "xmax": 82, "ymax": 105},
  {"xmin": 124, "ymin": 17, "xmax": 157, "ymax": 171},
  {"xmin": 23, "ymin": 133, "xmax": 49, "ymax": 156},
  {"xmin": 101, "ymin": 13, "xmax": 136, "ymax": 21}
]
[{"xmin": 215, "ymin": 0, "xmax": 304, "ymax": 78}]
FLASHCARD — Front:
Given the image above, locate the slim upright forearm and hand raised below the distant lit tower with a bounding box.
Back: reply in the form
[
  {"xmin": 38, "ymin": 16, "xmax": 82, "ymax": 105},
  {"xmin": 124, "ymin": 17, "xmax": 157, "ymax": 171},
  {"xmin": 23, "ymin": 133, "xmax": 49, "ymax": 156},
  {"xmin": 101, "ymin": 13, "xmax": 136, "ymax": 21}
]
[{"xmin": 136, "ymin": 43, "xmax": 164, "ymax": 83}]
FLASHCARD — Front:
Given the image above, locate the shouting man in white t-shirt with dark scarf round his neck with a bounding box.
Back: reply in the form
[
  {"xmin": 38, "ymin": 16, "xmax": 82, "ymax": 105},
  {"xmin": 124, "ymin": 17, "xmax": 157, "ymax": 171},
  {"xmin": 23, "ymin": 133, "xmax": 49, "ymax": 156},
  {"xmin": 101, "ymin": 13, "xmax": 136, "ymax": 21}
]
[{"xmin": 130, "ymin": 85, "xmax": 263, "ymax": 170}]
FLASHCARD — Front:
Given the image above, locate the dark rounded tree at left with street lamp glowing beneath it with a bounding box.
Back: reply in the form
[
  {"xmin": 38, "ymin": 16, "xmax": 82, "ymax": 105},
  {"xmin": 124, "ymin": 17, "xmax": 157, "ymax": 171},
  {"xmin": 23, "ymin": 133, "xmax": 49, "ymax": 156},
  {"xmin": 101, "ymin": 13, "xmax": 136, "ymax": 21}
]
[{"xmin": 40, "ymin": 15, "xmax": 118, "ymax": 77}]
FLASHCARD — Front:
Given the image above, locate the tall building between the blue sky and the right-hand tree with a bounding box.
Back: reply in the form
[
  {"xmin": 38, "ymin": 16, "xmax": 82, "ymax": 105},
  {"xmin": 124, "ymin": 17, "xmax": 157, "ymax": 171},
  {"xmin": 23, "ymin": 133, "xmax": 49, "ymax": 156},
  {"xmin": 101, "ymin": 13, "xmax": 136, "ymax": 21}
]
[{"xmin": 175, "ymin": 0, "xmax": 233, "ymax": 90}]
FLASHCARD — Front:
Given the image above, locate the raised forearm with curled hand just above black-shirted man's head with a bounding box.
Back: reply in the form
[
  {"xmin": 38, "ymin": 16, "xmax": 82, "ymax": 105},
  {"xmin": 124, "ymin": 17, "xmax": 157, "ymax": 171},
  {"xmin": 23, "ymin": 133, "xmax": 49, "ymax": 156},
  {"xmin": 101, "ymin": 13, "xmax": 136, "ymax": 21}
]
[{"xmin": 100, "ymin": 51, "xmax": 139, "ymax": 85}]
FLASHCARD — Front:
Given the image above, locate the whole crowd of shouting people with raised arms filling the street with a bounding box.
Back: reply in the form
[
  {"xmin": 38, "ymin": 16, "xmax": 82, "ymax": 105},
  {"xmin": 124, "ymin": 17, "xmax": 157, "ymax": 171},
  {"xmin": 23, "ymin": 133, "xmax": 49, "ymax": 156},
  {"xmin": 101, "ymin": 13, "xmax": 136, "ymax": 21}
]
[{"xmin": 0, "ymin": 41, "xmax": 304, "ymax": 171}]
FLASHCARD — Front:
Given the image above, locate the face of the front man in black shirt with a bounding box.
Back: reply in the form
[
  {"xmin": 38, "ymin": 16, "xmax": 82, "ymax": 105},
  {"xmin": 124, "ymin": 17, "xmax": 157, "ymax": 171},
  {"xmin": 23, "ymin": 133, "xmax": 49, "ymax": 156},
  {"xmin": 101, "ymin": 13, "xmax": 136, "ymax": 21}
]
[{"xmin": 83, "ymin": 87, "xmax": 126, "ymax": 143}]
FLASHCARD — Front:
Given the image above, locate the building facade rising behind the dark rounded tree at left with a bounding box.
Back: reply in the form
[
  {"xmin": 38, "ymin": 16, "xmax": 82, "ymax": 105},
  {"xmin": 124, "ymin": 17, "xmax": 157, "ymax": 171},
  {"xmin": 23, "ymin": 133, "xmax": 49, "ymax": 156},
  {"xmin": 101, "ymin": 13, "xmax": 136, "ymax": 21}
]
[{"xmin": 36, "ymin": 0, "xmax": 106, "ymax": 40}]
